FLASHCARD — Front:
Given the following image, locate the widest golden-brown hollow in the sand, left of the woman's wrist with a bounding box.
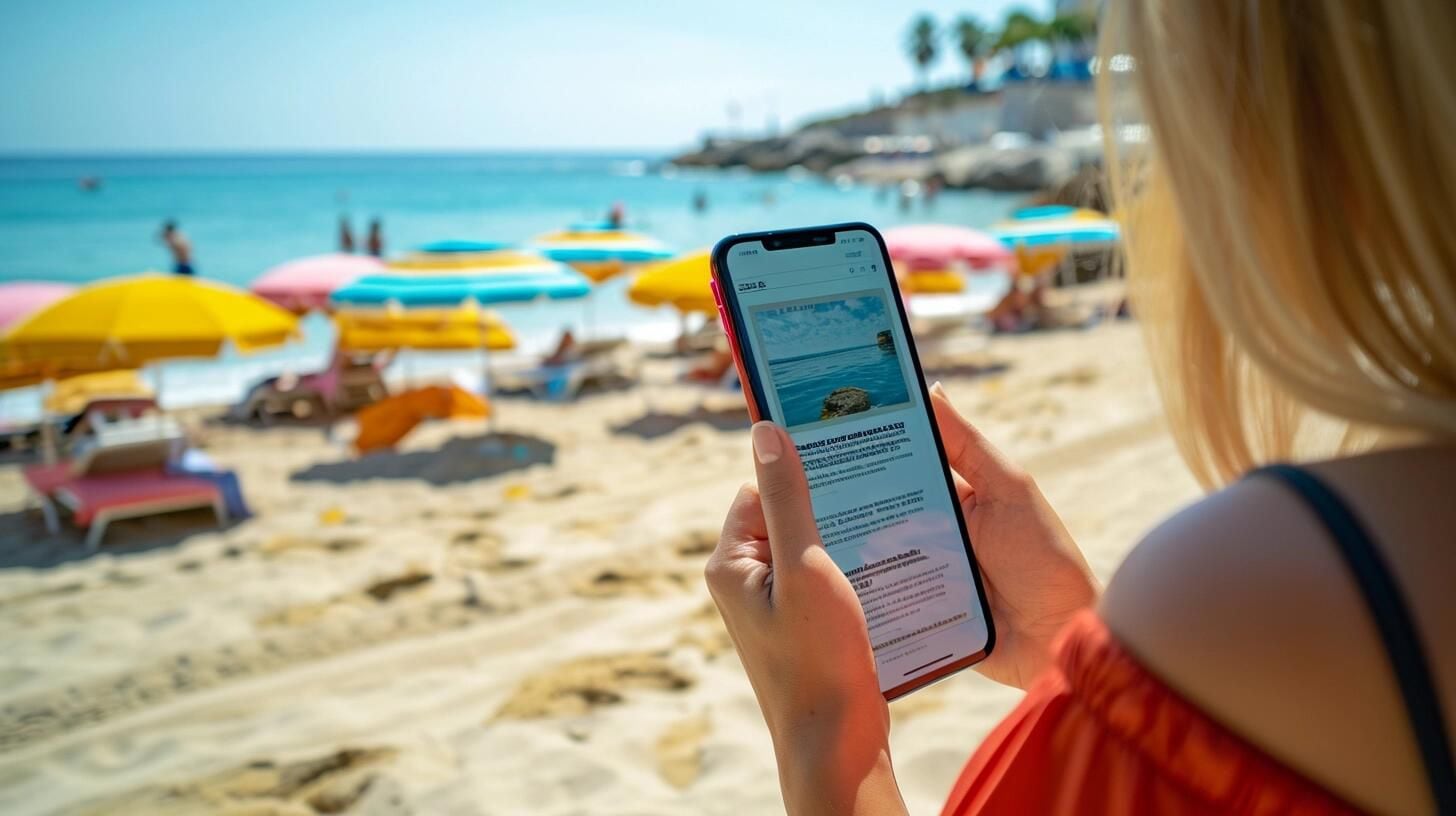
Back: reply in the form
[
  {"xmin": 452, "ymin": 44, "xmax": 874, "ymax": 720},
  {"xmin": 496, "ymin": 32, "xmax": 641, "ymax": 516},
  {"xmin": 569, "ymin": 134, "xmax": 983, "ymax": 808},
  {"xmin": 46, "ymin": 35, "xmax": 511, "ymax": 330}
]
[{"xmin": 494, "ymin": 651, "xmax": 696, "ymax": 720}]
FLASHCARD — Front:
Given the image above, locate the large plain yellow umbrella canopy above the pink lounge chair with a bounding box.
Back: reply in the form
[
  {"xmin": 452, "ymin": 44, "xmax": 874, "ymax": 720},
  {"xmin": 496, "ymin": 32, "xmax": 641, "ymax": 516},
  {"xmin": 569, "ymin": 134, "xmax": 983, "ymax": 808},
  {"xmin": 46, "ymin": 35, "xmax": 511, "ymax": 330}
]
[{"xmin": 0, "ymin": 272, "xmax": 298, "ymax": 372}]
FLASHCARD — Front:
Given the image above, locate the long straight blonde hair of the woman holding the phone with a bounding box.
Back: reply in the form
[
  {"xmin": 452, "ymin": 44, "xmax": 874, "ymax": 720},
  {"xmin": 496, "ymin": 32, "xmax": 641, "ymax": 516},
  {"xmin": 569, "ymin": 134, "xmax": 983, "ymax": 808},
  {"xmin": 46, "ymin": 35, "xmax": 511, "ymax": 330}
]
[{"xmin": 1099, "ymin": 0, "xmax": 1456, "ymax": 487}]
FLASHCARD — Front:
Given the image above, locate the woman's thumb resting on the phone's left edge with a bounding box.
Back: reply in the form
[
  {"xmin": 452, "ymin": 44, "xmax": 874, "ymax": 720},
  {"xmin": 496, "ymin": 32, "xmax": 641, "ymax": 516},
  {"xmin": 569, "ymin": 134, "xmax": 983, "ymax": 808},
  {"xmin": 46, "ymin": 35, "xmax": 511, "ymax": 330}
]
[{"xmin": 753, "ymin": 423, "xmax": 820, "ymax": 574}]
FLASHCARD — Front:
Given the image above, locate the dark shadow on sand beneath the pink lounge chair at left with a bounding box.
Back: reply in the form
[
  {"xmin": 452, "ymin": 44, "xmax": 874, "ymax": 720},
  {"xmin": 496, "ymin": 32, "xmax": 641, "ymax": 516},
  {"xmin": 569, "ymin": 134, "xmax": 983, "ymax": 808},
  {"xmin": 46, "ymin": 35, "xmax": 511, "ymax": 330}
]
[{"xmin": 0, "ymin": 507, "xmax": 227, "ymax": 570}]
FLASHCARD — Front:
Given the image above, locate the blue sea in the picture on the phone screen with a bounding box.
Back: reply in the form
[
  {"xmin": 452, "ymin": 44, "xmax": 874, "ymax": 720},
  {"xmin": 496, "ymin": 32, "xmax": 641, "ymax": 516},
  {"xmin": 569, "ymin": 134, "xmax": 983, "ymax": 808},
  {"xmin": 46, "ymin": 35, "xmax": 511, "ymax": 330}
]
[{"xmin": 769, "ymin": 344, "xmax": 910, "ymax": 428}]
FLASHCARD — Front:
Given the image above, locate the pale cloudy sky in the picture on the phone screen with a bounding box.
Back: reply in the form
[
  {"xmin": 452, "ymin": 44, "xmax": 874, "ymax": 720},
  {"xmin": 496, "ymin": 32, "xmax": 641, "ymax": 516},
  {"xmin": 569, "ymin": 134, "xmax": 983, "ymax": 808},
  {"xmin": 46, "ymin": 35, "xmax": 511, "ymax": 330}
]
[{"xmin": 753, "ymin": 296, "xmax": 890, "ymax": 360}]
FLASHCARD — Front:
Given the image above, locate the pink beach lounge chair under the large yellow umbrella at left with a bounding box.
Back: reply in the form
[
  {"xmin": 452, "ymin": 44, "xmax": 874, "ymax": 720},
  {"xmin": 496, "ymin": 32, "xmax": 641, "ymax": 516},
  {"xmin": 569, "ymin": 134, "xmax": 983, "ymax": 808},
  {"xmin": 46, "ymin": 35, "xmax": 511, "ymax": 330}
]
[{"xmin": 23, "ymin": 417, "xmax": 227, "ymax": 551}]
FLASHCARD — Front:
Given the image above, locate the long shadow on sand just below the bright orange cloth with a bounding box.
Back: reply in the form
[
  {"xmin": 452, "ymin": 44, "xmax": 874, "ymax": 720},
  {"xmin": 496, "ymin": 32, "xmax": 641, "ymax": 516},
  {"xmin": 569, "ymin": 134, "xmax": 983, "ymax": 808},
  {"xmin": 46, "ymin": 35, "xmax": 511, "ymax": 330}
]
[{"xmin": 290, "ymin": 434, "xmax": 556, "ymax": 485}]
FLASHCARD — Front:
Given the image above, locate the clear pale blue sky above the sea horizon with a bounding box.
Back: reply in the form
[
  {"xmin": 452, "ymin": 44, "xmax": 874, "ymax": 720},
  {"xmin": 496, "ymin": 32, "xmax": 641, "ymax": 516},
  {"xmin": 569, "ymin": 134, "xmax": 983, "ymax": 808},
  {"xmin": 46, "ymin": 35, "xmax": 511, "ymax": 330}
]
[{"xmin": 0, "ymin": 0, "xmax": 1051, "ymax": 153}]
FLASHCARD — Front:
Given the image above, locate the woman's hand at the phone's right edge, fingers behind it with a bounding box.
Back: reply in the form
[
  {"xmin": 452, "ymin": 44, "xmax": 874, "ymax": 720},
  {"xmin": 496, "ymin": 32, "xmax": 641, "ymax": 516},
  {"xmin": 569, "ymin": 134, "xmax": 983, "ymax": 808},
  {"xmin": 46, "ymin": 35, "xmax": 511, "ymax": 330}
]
[{"xmin": 930, "ymin": 383, "xmax": 1101, "ymax": 689}]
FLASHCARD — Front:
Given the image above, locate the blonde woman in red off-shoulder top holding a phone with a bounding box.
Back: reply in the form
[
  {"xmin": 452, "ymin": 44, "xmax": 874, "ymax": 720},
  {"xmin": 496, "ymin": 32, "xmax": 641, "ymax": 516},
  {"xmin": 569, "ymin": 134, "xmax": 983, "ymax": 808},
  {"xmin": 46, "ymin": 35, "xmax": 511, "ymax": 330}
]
[{"xmin": 708, "ymin": 0, "xmax": 1456, "ymax": 815}]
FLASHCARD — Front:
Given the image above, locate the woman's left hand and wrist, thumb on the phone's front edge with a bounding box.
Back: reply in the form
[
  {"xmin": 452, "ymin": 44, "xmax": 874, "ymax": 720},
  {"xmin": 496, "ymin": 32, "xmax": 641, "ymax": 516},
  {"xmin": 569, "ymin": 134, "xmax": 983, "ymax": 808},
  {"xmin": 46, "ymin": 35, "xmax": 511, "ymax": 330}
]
[{"xmin": 706, "ymin": 423, "xmax": 904, "ymax": 815}]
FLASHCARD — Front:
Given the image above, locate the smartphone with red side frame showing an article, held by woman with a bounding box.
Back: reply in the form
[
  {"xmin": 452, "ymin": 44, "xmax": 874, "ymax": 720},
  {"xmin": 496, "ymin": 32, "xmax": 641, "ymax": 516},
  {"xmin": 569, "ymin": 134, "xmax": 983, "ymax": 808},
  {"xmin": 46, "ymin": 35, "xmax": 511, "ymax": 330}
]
[{"xmin": 712, "ymin": 223, "xmax": 996, "ymax": 699}]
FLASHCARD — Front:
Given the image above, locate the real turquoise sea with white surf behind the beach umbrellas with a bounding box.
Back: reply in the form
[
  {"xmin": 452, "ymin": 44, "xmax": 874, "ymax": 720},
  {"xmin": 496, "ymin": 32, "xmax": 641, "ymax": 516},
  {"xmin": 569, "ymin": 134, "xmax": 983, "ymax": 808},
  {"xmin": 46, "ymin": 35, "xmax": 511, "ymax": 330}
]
[{"xmin": 0, "ymin": 152, "xmax": 1022, "ymax": 421}]
